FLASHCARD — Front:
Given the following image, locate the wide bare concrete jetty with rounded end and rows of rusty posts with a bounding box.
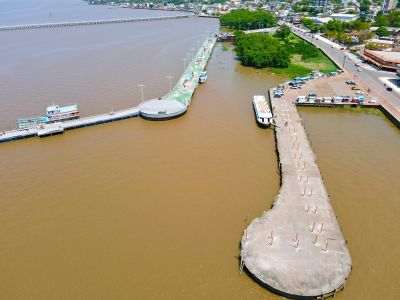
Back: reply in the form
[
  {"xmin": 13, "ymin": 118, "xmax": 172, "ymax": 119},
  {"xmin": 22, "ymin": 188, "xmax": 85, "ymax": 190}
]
[{"xmin": 241, "ymin": 91, "xmax": 352, "ymax": 299}]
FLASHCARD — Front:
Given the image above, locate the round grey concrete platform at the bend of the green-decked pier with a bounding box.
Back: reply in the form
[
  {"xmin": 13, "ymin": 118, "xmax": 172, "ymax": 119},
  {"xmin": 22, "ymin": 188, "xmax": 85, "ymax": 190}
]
[{"xmin": 139, "ymin": 99, "xmax": 187, "ymax": 120}]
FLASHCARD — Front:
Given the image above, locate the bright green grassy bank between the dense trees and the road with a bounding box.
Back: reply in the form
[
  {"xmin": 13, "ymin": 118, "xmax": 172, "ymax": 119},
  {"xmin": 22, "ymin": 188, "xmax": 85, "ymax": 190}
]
[{"xmin": 266, "ymin": 34, "xmax": 338, "ymax": 77}]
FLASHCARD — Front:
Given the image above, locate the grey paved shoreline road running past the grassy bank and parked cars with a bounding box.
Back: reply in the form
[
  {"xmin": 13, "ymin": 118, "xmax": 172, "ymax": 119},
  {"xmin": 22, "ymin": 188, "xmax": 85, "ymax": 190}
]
[{"xmin": 292, "ymin": 28, "xmax": 400, "ymax": 112}]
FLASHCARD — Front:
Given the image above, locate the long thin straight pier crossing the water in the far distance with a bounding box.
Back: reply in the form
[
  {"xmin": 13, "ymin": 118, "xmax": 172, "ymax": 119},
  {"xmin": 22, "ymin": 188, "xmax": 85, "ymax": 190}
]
[{"xmin": 0, "ymin": 15, "xmax": 191, "ymax": 31}]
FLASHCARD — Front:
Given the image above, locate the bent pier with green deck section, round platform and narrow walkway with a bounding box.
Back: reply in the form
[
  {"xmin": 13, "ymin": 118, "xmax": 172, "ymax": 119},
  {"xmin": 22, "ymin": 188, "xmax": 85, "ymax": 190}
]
[{"xmin": 0, "ymin": 34, "xmax": 216, "ymax": 143}]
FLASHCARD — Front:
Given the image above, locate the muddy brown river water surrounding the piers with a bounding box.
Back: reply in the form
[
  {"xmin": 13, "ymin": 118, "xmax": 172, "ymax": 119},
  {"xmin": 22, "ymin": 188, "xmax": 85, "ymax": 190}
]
[{"xmin": 0, "ymin": 0, "xmax": 400, "ymax": 299}]
